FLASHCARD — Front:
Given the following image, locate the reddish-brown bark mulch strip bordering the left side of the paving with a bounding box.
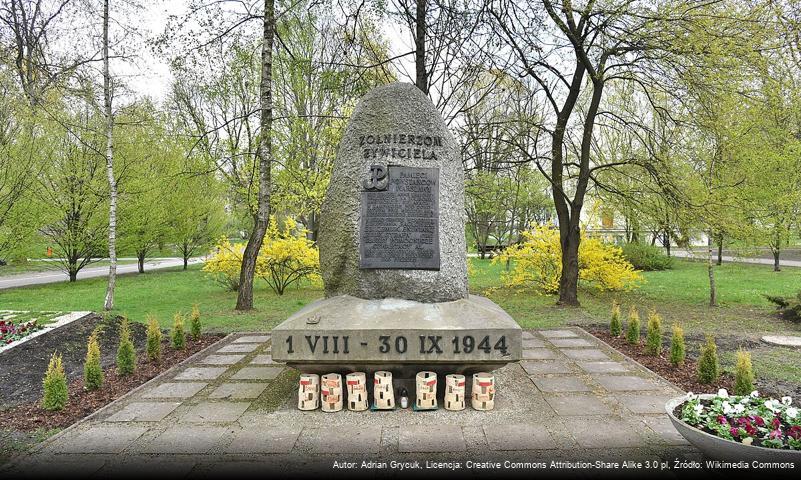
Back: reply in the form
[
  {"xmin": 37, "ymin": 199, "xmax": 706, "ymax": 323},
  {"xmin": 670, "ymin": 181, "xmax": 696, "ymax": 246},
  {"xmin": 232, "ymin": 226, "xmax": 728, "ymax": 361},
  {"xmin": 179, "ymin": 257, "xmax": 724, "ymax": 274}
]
[{"xmin": 0, "ymin": 335, "xmax": 222, "ymax": 431}]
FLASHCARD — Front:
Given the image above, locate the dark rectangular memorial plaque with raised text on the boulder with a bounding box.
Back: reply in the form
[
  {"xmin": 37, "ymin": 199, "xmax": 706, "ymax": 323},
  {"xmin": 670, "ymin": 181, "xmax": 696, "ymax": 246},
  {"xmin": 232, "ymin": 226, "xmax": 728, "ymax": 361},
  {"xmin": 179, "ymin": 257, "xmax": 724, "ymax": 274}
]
[{"xmin": 359, "ymin": 165, "xmax": 440, "ymax": 270}]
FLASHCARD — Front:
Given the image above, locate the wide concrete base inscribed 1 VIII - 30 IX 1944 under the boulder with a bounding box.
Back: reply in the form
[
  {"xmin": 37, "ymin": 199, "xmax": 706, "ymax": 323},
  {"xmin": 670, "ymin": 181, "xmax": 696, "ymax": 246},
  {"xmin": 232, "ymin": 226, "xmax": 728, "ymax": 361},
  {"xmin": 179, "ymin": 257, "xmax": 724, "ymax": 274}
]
[{"xmin": 272, "ymin": 295, "xmax": 522, "ymax": 378}]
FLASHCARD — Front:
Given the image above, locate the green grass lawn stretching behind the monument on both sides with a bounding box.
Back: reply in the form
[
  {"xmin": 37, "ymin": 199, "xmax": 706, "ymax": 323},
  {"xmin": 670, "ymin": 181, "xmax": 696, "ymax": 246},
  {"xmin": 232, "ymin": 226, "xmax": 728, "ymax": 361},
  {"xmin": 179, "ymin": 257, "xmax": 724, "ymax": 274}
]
[{"xmin": 0, "ymin": 259, "xmax": 801, "ymax": 384}]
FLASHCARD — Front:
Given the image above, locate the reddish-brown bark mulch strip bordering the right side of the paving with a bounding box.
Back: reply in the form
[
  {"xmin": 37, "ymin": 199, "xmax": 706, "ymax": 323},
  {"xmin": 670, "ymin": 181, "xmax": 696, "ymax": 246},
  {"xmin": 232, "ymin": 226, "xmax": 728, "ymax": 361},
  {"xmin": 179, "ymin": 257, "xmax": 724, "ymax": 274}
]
[{"xmin": 589, "ymin": 327, "xmax": 736, "ymax": 393}]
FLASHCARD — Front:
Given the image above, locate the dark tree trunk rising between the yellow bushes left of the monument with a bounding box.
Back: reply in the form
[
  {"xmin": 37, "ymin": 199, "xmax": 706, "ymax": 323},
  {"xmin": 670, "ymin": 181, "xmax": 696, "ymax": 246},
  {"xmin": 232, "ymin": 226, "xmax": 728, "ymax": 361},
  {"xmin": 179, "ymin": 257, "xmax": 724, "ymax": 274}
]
[{"xmin": 236, "ymin": 0, "xmax": 275, "ymax": 310}]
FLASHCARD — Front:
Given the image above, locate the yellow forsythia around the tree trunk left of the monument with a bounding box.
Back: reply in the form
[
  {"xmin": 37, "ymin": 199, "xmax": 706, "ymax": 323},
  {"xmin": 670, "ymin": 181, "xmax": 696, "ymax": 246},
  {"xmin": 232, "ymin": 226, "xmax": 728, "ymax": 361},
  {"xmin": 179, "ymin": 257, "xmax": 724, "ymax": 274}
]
[{"xmin": 203, "ymin": 217, "xmax": 320, "ymax": 295}]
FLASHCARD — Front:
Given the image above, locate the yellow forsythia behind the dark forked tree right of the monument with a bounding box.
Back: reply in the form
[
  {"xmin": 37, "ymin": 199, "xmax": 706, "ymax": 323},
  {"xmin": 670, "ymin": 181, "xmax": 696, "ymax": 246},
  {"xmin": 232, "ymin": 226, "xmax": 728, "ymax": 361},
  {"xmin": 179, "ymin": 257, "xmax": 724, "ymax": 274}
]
[{"xmin": 493, "ymin": 226, "xmax": 643, "ymax": 293}]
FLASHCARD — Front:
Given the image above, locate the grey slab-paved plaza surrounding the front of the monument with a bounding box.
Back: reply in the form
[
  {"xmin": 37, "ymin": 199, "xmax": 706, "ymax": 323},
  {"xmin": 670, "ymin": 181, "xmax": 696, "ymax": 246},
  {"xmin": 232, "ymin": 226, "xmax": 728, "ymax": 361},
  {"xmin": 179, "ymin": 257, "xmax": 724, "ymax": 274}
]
[{"xmin": 0, "ymin": 327, "xmax": 700, "ymax": 477}]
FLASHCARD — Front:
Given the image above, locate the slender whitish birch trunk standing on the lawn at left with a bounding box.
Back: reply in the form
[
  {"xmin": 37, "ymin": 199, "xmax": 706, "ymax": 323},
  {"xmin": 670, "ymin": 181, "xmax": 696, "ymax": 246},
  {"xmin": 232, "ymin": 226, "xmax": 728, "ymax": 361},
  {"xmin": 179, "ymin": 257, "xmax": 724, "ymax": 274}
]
[{"xmin": 103, "ymin": 0, "xmax": 117, "ymax": 311}]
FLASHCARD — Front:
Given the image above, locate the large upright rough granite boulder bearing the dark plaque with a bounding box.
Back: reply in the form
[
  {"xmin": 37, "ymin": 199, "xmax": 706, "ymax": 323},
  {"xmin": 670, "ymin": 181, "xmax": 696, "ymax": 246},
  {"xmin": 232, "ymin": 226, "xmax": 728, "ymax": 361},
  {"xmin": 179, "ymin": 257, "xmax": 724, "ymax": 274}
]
[{"xmin": 318, "ymin": 83, "xmax": 468, "ymax": 302}]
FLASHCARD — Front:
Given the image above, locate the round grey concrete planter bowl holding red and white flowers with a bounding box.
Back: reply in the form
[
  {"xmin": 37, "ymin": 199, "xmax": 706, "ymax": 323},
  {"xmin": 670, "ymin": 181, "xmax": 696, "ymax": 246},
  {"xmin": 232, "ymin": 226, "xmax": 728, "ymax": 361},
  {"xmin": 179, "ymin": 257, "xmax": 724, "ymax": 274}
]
[{"xmin": 665, "ymin": 394, "xmax": 801, "ymax": 464}]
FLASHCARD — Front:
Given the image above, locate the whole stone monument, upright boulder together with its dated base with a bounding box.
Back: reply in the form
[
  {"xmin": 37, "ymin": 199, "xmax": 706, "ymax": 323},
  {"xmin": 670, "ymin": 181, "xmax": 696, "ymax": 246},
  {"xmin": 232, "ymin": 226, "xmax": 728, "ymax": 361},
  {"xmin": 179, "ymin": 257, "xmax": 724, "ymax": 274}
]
[{"xmin": 272, "ymin": 83, "xmax": 522, "ymax": 378}]
